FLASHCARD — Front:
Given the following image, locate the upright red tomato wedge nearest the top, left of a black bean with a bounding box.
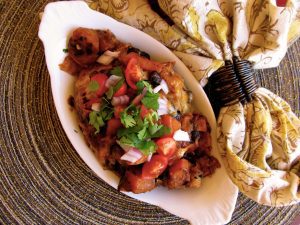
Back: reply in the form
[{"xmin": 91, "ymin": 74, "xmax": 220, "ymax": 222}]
[{"xmin": 125, "ymin": 57, "xmax": 143, "ymax": 90}]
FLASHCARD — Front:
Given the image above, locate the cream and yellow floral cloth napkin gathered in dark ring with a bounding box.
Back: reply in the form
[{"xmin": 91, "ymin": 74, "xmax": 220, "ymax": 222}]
[{"xmin": 86, "ymin": 0, "xmax": 300, "ymax": 206}]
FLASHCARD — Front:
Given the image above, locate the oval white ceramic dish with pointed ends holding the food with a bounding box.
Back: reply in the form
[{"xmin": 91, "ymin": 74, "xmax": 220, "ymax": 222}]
[{"xmin": 39, "ymin": 1, "xmax": 238, "ymax": 225}]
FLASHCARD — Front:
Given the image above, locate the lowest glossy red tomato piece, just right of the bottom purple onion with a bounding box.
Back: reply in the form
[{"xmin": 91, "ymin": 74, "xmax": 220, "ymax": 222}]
[{"xmin": 142, "ymin": 155, "xmax": 168, "ymax": 179}]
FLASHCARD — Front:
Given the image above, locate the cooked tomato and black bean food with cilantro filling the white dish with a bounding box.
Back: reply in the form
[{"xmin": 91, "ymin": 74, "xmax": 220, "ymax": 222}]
[{"xmin": 60, "ymin": 28, "xmax": 220, "ymax": 193}]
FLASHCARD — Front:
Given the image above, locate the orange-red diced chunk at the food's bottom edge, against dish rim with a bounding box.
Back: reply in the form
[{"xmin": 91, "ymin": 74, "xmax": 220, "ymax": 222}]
[{"xmin": 121, "ymin": 171, "xmax": 155, "ymax": 194}]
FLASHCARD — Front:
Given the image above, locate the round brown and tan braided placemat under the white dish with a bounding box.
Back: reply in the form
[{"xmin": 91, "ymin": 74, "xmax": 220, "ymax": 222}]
[{"xmin": 0, "ymin": 0, "xmax": 300, "ymax": 224}]
